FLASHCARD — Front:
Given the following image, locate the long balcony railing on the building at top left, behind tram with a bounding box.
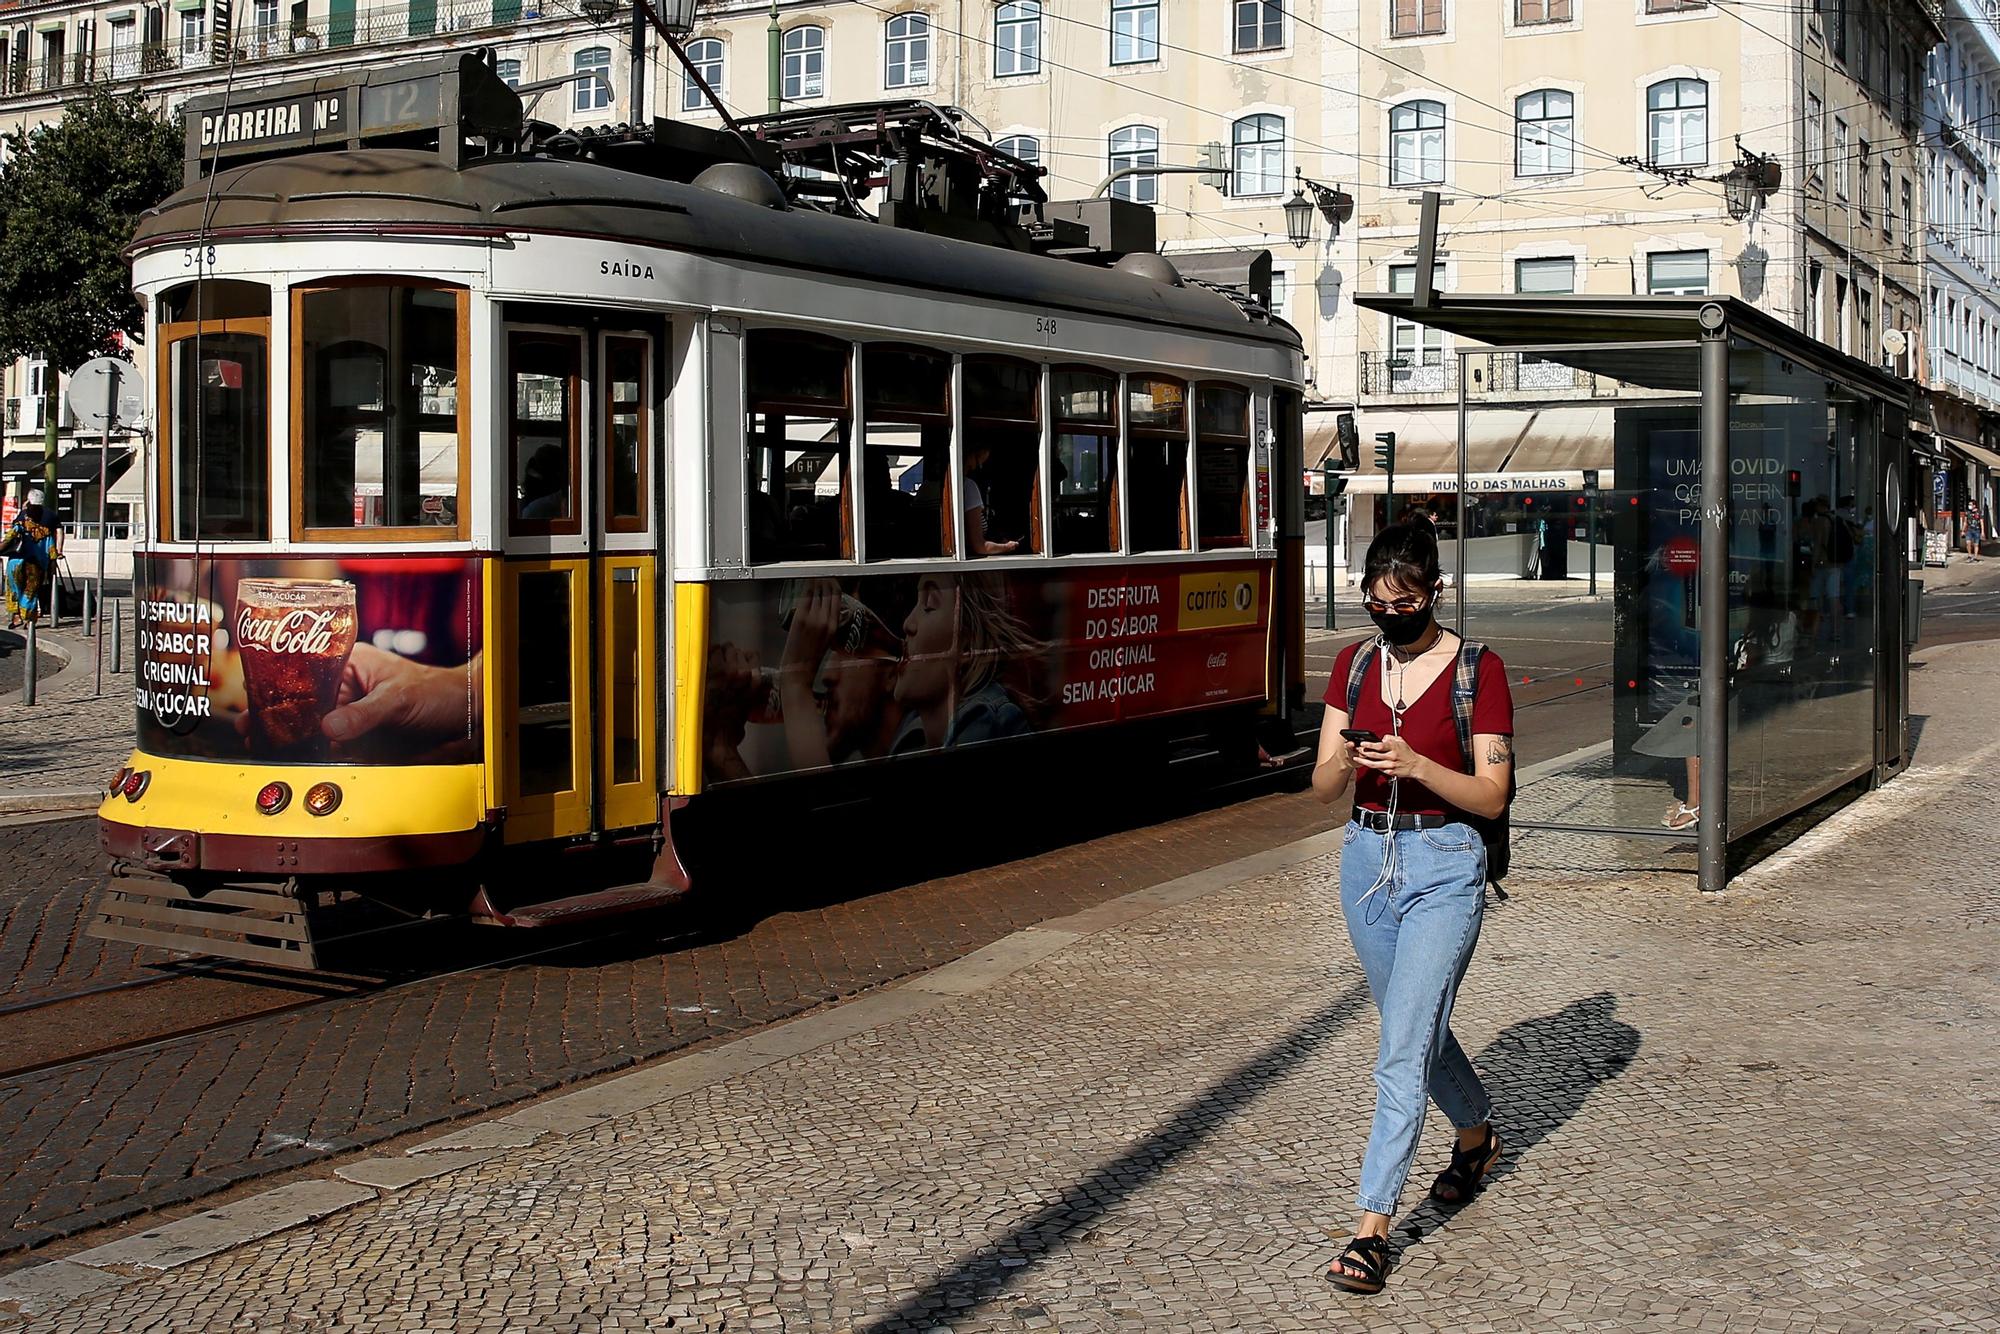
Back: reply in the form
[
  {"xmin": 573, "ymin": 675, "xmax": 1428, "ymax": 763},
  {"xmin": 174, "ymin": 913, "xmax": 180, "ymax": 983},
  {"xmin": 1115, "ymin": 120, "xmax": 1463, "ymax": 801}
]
[{"xmin": 0, "ymin": 0, "xmax": 558, "ymax": 96}]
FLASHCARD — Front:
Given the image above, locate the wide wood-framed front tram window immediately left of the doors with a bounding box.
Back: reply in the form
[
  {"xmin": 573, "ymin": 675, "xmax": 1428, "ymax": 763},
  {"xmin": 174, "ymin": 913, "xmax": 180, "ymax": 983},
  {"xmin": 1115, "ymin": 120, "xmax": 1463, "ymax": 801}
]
[{"xmin": 292, "ymin": 282, "xmax": 470, "ymax": 538}]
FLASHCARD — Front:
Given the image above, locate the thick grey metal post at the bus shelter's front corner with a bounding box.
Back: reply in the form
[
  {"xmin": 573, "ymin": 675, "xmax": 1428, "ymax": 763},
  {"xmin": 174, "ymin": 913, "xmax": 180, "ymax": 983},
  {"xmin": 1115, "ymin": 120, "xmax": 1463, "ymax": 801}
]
[{"xmin": 1696, "ymin": 318, "xmax": 1730, "ymax": 894}]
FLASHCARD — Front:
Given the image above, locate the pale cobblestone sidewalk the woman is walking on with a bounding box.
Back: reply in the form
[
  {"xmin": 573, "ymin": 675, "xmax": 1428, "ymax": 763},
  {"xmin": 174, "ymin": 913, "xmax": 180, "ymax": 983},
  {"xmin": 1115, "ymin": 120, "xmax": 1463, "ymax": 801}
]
[{"xmin": 15, "ymin": 644, "xmax": 2000, "ymax": 1334}]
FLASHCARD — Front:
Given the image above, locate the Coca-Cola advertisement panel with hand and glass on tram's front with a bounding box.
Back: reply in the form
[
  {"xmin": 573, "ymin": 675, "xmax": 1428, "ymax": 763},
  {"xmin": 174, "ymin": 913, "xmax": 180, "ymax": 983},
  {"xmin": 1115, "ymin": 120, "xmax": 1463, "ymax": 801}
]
[{"xmin": 134, "ymin": 554, "xmax": 482, "ymax": 764}]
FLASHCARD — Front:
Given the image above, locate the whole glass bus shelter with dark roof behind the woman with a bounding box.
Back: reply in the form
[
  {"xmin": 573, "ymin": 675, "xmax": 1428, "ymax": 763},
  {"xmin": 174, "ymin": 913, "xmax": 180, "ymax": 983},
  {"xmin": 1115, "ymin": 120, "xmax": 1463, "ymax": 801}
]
[{"xmin": 1356, "ymin": 294, "xmax": 1914, "ymax": 890}]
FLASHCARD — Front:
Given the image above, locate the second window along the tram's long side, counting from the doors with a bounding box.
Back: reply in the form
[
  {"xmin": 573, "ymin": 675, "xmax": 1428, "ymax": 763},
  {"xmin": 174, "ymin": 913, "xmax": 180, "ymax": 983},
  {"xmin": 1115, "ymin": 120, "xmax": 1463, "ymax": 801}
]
[{"xmin": 862, "ymin": 344, "xmax": 954, "ymax": 560}]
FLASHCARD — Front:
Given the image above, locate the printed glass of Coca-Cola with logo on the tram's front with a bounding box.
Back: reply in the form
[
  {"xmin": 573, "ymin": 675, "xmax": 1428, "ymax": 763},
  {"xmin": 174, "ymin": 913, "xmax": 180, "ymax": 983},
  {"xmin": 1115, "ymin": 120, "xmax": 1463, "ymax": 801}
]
[{"xmin": 236, "ymin": 578, "xmax": 354, "ymax": 760}]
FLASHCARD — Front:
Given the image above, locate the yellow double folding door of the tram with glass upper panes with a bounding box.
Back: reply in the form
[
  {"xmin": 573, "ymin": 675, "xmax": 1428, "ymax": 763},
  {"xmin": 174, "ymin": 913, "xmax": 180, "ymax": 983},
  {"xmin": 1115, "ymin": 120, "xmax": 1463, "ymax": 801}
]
[{"xmin": 496, "ymin": 324, "xmax": 660, "ymax": 842}]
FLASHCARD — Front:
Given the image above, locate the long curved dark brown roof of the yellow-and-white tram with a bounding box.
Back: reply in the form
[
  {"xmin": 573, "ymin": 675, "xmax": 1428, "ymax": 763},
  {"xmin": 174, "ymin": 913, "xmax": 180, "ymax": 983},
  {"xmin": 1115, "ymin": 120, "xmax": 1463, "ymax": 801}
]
[{"xmin": 130, "ymin": 148, "xmax": 1300, "ymax": 348}]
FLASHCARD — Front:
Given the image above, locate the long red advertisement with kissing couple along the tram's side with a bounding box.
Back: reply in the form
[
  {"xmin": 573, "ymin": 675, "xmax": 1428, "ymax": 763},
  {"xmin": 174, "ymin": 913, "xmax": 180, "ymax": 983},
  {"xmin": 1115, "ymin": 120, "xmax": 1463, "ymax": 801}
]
[{"xmin": 702, "ymin": 564, "xmax": 1270, "ymax": 784}]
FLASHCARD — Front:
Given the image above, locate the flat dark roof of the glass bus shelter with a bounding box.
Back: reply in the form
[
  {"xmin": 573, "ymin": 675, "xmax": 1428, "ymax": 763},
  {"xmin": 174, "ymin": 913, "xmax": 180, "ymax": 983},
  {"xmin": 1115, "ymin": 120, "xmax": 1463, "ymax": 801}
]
[{"xmin": 1354, "ymin": 292, "xmax": 1912, "ymax": 406}]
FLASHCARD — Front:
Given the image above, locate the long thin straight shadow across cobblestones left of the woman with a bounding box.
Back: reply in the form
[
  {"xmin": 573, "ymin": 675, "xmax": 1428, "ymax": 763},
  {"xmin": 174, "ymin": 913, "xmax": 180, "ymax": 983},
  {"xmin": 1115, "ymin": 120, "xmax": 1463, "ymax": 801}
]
[{"xmin": 864, "ymin": 982, "xmax": 1368, "ymax": 1334}]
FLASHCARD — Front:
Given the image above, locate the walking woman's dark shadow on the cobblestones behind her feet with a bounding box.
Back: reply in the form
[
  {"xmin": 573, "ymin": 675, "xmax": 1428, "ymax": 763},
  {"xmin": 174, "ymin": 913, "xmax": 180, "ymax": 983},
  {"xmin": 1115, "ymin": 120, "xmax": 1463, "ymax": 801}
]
[{"xmin": 1396, "ymin": 992, "xmax": 1640, "ymax": 1252}]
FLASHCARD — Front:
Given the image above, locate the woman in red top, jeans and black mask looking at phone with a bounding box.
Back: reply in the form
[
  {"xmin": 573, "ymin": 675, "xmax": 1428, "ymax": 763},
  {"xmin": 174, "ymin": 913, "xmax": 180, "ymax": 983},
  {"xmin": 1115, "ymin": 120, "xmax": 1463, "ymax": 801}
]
[{"xmin": 1312, "ymin": 524, "xmax": 1514, "ymax": 1292}]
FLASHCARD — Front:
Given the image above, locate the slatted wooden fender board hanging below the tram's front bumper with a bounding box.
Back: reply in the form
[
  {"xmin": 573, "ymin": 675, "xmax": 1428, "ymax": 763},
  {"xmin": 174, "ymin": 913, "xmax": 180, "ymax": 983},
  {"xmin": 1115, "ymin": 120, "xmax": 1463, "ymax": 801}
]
[{"xmin": 86, "ymin": 870, "xmax": 320, "ymax": 970}]
